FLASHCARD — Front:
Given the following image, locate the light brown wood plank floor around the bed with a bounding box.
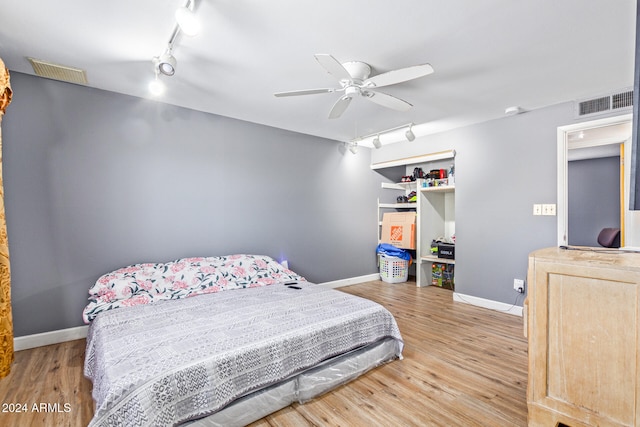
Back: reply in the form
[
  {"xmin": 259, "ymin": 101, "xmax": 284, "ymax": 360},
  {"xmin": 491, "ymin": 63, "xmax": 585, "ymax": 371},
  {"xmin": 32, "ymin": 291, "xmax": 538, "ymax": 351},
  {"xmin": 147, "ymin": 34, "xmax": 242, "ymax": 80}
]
[{"xmin": 0, "ymin": 281, "xmax": 527, "ymax": 427}]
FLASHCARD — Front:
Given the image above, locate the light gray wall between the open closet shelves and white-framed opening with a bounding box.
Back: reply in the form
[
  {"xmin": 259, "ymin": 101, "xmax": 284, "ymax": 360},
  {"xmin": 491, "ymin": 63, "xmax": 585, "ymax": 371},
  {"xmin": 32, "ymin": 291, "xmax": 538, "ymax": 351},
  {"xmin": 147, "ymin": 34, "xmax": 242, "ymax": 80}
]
[{"xmin": 371, "ymin": 103, "xmax": 575, "ymax": 305}]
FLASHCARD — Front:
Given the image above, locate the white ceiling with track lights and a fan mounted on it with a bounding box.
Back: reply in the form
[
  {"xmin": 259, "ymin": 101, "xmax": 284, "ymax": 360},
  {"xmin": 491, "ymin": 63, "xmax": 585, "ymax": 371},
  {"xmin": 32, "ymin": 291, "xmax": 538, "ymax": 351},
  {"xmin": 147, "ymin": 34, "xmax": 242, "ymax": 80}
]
[{"xmin": 0, "ymin": 0, "xmax": 636, "ymax": 149}]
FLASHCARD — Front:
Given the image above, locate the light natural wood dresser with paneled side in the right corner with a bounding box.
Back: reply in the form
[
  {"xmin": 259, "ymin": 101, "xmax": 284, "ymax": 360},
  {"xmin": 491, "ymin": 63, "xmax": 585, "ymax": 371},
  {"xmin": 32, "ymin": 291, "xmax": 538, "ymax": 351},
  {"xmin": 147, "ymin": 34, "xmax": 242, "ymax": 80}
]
[{"xmin": 526, "ymin": 248, "xmax": 640, "ymax": 427}]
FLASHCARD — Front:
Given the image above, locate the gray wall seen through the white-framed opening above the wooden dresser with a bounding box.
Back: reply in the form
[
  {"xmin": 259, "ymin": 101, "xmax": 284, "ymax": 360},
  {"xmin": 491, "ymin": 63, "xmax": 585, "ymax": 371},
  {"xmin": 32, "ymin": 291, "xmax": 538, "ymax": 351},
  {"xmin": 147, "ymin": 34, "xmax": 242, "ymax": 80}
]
[{"xmin": 567, "ymin": 156, "xmax": 620, "ymax": 247}]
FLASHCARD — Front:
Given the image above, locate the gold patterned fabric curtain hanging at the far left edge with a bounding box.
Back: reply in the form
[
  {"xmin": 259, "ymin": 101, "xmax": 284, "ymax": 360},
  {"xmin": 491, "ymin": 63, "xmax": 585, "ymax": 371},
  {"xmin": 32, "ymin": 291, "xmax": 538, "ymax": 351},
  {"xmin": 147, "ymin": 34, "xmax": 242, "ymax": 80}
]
[{"xmin": 0, "ymin": 59, "xmax": 13, "ymax": 378}]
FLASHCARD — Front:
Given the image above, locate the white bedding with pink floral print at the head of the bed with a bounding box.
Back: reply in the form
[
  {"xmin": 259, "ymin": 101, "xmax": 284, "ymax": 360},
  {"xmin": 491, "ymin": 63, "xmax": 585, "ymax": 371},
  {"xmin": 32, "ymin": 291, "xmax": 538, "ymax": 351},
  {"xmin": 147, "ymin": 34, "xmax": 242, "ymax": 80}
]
[{"xmin": 82, "ymin": 255, "xmax": 305, "ymax": 323}]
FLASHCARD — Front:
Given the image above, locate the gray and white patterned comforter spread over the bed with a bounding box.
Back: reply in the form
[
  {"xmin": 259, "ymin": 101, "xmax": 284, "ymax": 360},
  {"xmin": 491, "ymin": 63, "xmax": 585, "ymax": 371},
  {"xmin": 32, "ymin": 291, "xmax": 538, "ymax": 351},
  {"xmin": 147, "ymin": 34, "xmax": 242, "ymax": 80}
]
[{"xmin": 85, "ymin": 283, "xmax": 402, "ymax": 426}]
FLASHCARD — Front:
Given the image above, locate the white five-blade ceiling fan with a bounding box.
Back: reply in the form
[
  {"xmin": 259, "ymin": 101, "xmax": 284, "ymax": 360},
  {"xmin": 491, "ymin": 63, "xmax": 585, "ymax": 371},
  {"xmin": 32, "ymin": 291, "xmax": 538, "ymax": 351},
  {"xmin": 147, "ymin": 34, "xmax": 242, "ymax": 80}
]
[{"xmin": 274, "ymin": 54, "xmax": 433, "ymax": 119}]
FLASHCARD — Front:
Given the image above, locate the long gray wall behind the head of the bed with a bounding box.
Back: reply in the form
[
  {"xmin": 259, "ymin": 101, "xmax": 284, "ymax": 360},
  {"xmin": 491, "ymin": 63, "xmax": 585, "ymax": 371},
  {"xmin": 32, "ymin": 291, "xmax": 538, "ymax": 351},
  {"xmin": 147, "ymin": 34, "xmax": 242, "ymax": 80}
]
[{"xmin": 3, "ymin": 73, "xmax": 384, "ymax": 336}]
